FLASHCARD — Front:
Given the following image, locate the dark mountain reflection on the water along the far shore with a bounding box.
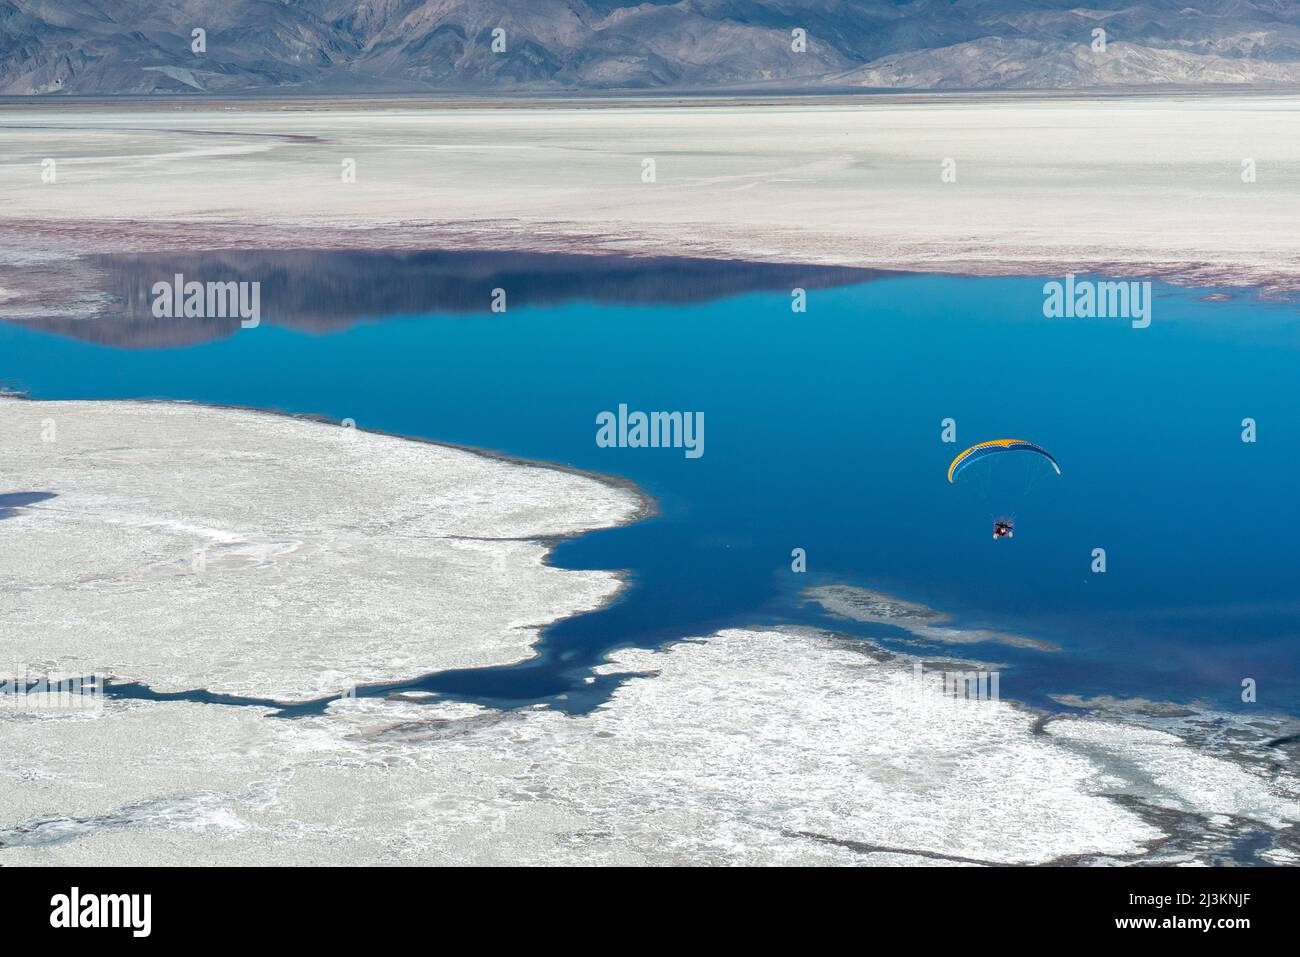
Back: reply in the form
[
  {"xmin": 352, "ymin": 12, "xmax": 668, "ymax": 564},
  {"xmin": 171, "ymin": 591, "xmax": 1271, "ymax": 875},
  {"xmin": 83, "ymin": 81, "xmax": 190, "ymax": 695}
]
[{"xmin": 0, "ymin": 250, "xmax": 883, "ymax": 348}]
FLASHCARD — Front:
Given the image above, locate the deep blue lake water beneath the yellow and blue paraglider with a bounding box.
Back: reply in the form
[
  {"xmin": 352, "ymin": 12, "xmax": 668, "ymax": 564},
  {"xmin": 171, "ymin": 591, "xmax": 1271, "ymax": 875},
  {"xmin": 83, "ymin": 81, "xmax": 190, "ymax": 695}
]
[{"xmin": 0, "ymin": 257, "xmax": 1300, "ymax": 714}]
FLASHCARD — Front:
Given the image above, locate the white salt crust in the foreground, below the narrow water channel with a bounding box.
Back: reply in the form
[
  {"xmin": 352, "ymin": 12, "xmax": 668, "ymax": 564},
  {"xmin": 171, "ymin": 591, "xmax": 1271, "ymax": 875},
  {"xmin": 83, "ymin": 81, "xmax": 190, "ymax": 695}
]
[{"xmin": 0, "ymin": 631, "xmax": 1296, "ymax": 865}]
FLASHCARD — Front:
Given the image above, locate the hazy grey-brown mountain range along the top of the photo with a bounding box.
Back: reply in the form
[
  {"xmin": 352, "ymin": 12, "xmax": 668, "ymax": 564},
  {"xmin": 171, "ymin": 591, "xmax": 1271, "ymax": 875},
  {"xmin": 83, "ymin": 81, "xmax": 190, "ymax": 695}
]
[{"xmin": 0, "ymin": 0, "xmax": 1300, "ymax": 95}]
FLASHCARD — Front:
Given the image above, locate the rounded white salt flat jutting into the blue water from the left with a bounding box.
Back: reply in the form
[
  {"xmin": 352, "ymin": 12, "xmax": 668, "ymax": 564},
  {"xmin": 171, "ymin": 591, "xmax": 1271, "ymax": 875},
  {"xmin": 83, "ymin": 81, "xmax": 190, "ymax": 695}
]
[{"xmin": 0, "ymin": 399, "xmax": 642, "ymax": 700}]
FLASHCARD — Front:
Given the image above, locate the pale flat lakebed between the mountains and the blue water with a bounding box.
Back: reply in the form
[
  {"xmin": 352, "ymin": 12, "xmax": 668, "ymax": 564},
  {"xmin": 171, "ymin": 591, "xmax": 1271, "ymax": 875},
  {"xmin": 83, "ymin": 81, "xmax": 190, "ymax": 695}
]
[{"xmin": 0, "ymin": 91, "xmax": 1300, "ymax": 299}]
